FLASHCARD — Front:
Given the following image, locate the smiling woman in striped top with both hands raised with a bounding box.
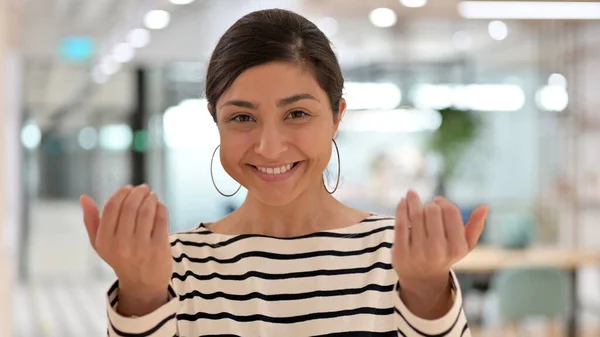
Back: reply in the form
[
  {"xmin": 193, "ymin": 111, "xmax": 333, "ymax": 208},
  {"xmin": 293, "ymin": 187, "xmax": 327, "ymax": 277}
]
[{"xmin": 81, "ymin": 10, "xmax": 487, "ymax": 337}]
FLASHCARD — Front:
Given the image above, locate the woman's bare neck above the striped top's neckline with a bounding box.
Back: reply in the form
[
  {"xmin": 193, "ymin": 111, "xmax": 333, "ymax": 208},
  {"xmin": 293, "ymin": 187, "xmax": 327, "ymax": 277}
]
[{"xmin": 211, "ymin": 182, "xmax": 368, "ymax": 237}]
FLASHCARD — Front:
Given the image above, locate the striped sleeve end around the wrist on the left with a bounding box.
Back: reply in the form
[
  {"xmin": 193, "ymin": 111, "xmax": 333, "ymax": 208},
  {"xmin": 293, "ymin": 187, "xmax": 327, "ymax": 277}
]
[{"xmin": 106, "ymin": 281, "xmax": 179, "ymax": 337}]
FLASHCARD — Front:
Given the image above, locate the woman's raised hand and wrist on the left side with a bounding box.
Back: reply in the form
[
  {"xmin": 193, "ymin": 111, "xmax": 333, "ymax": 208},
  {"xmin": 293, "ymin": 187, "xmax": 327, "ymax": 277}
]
[{"xmin": 81, "ymin": 185, "xmax": 173, "ymax": 316}]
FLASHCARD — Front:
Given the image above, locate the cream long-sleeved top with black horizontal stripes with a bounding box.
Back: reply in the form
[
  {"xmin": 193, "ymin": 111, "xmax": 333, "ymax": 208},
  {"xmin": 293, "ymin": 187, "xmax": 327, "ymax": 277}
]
[{"xmin": 107, "ymin": 216, "xmax": 470, "ymax": 337}]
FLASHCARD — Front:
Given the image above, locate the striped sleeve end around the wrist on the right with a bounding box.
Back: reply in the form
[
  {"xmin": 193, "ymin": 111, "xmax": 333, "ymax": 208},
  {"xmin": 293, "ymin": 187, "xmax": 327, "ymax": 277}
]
[{"xmin": 395, "ymin": 272, "xmax": 471, "ymax": 337}]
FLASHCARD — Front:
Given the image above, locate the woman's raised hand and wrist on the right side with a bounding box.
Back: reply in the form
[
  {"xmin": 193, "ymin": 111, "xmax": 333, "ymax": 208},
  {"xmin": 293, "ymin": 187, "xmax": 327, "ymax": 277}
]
[{"xmin": 392, "ymin": 190, "xmax": 488, "ymax": 297}]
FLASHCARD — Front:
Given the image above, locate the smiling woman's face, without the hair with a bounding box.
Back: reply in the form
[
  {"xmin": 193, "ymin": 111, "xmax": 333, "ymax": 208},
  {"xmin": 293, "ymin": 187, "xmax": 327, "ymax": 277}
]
[{"xmin": 216, "ymin": 62, "xmax": 345, "ymax": 205}]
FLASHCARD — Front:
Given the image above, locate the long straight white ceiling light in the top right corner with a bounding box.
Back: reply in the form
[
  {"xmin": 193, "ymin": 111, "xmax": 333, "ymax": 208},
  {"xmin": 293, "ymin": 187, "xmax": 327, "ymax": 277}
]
[{"xmin": 458, "ymin": 1, "xmax": 600, "ymax": 20}]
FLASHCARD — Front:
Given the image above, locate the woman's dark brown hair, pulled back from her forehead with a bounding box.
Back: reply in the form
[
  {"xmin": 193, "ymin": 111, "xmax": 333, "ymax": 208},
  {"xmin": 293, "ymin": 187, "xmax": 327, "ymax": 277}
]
[{"xmin": 206, "ymin": 9, "xmax": 344, "ymax": 122}]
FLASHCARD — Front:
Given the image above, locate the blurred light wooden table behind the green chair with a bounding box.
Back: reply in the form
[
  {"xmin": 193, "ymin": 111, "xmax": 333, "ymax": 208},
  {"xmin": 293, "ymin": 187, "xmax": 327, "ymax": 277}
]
[{"xmin": 453, "ymin": 246, "xmax": 600, "ymax": 337}]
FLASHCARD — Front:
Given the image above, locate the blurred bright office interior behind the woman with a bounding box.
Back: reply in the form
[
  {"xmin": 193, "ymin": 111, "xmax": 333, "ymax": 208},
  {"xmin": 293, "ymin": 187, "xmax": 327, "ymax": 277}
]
[{"xmin": 0, "ymin": 0, "xmax": 600, "ymax": 337}]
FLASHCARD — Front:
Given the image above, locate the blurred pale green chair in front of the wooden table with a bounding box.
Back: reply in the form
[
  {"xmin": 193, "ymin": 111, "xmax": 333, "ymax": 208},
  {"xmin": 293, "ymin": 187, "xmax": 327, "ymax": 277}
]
[{"xmin": 491, "ymin": 267, "xmax": 573, "ymax": 336}]
